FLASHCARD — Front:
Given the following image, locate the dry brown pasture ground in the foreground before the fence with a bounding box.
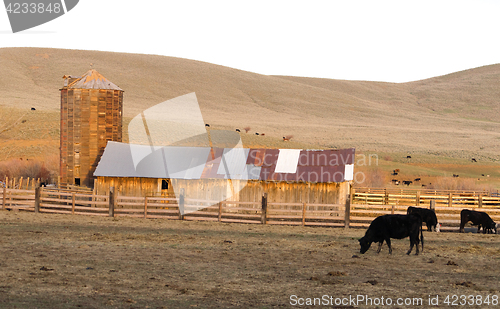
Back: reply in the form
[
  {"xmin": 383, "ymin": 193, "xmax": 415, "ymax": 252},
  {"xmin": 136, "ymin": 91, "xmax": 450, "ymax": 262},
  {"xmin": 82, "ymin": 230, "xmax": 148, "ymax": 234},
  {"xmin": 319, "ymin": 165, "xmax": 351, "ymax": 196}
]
[{"xmin": 0, "ymin": 211, "xmax": 500, "ymax": 308}]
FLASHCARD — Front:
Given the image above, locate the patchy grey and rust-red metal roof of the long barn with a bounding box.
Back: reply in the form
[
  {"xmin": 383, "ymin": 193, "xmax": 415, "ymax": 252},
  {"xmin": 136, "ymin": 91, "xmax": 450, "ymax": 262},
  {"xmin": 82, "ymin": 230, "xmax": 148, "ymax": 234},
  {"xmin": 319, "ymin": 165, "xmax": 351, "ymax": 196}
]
[{"xmin": 94, "ymin": 141, "xmax": 355, "ymax": 182}]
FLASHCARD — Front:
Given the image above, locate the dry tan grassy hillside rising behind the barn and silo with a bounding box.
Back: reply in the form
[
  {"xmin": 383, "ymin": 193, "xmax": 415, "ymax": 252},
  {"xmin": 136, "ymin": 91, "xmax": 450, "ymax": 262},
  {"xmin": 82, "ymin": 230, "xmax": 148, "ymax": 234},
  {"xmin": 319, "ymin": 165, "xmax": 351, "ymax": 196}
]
[{"xmin": 0, "ymin": 48, "xmax": 500, "ymax": 189}]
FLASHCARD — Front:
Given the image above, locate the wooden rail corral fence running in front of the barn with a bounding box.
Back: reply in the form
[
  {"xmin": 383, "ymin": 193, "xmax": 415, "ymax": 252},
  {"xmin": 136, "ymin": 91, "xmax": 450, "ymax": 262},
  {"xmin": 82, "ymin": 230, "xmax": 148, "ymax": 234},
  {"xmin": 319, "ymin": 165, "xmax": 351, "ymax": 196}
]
[{"xmin": 1, "ymin": 186, "xmax": 500, "ymax": 231}]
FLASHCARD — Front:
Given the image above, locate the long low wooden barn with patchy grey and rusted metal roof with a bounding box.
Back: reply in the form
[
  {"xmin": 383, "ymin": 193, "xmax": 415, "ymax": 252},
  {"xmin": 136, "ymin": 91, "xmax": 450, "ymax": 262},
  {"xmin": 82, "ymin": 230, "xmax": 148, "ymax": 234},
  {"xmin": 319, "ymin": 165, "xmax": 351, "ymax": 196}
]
[{"xmin": 94, "ymin": 141, "xmax": 355, "ymax": 204}]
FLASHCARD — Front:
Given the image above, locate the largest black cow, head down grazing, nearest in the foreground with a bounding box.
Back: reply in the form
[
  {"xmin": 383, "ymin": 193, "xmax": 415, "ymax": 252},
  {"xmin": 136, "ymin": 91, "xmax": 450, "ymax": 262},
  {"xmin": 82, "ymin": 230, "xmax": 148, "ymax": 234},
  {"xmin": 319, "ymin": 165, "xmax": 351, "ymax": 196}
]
[{"xmin": 359, "ymin": 214, "xmax": 424, "ymax": 255}]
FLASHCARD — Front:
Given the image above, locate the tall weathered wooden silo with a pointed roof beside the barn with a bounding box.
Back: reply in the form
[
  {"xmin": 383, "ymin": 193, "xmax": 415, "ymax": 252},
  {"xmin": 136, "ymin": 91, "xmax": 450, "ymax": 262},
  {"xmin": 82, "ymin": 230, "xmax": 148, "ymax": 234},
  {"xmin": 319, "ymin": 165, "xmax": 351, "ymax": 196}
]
[{"xmin": 60, "ymin": 69, "xmax": 123, "ymax": 187}]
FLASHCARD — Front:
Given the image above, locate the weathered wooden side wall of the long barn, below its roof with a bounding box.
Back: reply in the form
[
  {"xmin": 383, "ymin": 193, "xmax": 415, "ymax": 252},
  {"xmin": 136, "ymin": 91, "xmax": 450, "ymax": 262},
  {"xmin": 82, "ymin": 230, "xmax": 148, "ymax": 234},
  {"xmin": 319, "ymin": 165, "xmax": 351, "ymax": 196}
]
[{"xmin": 96, "ymin": 177, "xmax": 349, "ymax": 204}]
